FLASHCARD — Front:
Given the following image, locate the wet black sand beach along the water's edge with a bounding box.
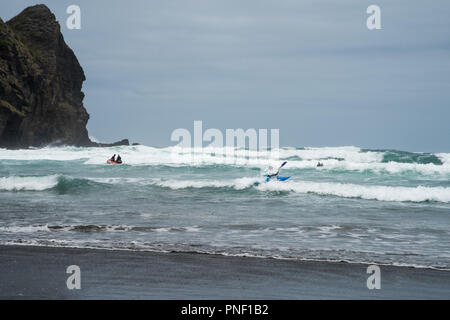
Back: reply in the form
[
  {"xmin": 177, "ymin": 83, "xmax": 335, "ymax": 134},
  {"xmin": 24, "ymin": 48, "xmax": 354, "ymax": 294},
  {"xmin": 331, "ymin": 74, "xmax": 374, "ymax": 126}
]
[{"xmin": 0, "ymin": 246, "xmax": 450, "ymax": 299}]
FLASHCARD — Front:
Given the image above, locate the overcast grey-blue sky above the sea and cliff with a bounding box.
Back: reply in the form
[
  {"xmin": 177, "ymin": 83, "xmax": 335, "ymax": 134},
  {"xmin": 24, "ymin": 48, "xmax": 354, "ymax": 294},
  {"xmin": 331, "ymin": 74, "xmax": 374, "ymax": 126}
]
[{"xmin": 0, "ymin": 0, "xmax": 450, "ymax": 152}]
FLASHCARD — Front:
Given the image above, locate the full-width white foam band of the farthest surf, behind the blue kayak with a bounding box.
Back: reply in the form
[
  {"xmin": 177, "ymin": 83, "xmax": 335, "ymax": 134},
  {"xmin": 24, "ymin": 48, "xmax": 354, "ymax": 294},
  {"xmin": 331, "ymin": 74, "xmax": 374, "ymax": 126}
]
[{"xmin": 0, "ymin": 145, "xmax": 450, "ymax": 176}]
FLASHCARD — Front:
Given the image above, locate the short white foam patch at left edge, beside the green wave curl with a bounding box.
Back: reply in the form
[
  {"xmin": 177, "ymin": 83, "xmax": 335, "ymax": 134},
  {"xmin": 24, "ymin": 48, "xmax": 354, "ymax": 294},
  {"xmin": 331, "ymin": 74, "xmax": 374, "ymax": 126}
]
[{"xmin": 0, "ymin": 175, "xmax": 58, "ymax": 191}]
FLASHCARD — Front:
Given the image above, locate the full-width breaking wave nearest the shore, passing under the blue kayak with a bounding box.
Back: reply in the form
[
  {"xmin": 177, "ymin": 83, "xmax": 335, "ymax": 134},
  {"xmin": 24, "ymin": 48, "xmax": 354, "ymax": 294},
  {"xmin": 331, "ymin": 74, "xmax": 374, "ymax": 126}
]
[{"xmin": 0, "ymin": 175, "xmax": 450, "ymax": 203}]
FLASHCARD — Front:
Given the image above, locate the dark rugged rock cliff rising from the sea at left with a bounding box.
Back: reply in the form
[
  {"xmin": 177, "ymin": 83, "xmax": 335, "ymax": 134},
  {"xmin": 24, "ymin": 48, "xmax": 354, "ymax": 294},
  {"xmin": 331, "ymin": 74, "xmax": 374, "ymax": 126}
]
[{"xmin": 0, "ymin": 5, "xmax": 128, "ymax": 148}]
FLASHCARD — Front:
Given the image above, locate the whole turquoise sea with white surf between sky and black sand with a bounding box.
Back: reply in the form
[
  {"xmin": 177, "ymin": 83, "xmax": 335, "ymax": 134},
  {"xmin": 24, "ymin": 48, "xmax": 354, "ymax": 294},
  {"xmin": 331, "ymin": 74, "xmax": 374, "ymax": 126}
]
[{"xmin": 0, "ymin": 146, "xmax": 450, "ymax": 269}]
